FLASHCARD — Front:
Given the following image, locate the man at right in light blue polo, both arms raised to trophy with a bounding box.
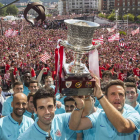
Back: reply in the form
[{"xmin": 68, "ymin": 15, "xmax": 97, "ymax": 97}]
[{"xmin": 69, "ymin": 74, "xmax": 140, "ymax": 140}]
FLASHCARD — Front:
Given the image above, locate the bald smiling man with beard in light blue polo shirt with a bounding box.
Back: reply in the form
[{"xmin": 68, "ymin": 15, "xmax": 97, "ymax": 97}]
[{"xmin": 0, "ymin": 93, "xmax": 34, "ymax": 140}]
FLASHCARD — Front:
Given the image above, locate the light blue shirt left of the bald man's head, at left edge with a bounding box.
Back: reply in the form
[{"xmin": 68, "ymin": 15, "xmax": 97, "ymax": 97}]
[{"xmin": 2, "ymin": 96, "xmax": 13, "ymax": 116}]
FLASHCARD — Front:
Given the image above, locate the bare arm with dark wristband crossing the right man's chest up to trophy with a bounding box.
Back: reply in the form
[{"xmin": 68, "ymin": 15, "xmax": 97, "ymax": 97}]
[{"xmin": 92, "ymin": 74, "xmax": 136, "ymax": 133}]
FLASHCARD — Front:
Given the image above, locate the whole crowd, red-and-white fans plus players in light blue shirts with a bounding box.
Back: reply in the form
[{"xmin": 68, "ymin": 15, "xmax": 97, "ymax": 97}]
[{"xmin": 0, "ymin": 12, "xmax": 140, "ymax": 140}]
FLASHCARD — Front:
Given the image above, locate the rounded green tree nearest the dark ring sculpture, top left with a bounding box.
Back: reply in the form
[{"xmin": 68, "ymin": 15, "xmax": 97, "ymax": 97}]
[{"xmin": 6, "ymin": 4, "xmax": 18, "ymax": 15}]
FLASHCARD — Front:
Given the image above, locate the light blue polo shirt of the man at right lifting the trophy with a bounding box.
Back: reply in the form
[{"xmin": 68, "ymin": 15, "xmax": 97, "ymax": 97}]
[{"xmin": 88, "ymin": 108, "xmax": 140, "ymax": 140}]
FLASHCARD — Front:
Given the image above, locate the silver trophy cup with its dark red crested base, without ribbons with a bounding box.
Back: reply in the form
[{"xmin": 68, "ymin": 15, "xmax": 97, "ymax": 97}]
[{"xmin": 59, "ymin": 19, "xmax": 100, "ymax": 96}]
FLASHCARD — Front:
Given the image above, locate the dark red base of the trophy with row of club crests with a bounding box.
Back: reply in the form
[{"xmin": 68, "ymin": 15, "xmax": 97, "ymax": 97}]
[{"xmin": 60, "ymin": 69, "xmax": 95, "ymax": 96}]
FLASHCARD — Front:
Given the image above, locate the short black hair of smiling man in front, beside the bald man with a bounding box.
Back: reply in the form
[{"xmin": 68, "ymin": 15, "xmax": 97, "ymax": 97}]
[{"xmin": 33, "ymin": 88, "xmax": 56, "ymax": 110}]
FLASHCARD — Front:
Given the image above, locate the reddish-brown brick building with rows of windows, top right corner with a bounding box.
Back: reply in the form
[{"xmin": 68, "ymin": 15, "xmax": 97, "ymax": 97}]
[{"xmin": 115, "ymin": 0, "xmax": 140, "ymax": 15}]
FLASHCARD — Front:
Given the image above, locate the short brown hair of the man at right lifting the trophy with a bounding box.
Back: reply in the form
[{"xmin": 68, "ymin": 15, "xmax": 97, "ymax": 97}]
[{"xmin": 105, "ymin": 79, "xmax": 125, "ymax": 96}]
